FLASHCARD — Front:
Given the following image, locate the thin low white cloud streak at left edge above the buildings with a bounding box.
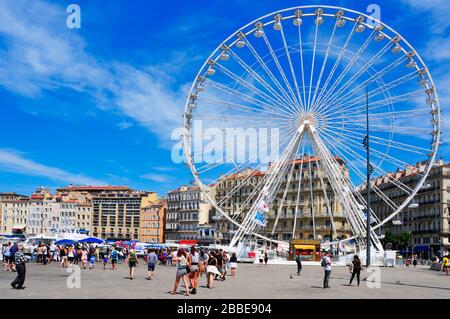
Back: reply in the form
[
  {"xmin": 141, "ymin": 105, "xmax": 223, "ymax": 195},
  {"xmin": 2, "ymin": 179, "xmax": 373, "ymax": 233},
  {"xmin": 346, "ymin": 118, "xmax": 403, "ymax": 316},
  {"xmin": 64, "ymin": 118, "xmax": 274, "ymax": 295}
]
[{"xmin": 0, "ymin": 149, "xmax": 105, "ymax": 185}]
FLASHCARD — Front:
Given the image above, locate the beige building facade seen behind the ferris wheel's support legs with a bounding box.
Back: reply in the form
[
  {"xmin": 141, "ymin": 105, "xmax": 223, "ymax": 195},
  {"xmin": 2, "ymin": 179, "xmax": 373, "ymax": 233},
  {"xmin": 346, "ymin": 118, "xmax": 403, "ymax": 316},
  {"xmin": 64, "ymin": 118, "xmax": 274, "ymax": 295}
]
[{"xmin": 213, "ymin": 157, "xmax": 350, "ymax": 244}]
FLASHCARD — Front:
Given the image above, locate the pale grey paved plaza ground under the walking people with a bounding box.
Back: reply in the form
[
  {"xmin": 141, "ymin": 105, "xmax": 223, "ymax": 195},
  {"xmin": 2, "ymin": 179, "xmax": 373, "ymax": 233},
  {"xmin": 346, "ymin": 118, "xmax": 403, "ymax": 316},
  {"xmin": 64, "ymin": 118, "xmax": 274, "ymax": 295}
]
[{"xmin": 0, "ymin": 263, "xmax": 450, "ymax": 299}]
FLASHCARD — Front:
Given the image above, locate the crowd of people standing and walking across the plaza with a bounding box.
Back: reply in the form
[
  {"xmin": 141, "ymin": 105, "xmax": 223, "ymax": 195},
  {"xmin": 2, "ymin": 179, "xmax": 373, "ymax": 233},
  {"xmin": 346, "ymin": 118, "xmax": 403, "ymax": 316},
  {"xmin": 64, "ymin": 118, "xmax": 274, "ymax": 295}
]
[{"xmin": 0, "ymin": 242, "xmax": 450, "ymax": 296}]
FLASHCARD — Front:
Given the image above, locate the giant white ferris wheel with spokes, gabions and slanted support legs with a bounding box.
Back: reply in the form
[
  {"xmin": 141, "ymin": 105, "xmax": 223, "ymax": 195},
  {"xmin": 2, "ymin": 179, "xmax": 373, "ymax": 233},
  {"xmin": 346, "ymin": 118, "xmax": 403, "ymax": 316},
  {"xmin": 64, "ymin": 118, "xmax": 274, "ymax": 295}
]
[{"xmin": 183, "ymin": 5, "xmax": 441, "ymax": 251}]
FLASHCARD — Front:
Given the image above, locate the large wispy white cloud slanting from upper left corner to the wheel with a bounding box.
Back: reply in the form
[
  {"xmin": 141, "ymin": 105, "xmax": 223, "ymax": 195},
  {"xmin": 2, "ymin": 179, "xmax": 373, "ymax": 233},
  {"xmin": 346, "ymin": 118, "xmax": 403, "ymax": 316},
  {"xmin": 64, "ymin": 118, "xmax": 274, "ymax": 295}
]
[{"xmin": 0, "ymin": 1, "xmax": 185, "ymax": 148}]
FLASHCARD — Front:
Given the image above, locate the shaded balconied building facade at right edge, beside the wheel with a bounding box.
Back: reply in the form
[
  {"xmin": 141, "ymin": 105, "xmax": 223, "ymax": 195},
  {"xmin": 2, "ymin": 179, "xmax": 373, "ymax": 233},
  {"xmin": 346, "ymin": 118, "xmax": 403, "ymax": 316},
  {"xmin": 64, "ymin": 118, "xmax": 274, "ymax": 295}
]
[{"xmin": 371, "ymin": 160, "xmax": 450, "ymax": 256}]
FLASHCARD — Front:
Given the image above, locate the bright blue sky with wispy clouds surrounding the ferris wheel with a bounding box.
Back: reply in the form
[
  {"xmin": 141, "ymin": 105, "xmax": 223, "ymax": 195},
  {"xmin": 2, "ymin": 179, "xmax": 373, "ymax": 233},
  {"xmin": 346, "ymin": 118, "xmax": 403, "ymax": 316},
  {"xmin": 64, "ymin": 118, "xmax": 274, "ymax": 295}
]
[{"xmin": 0, "ymin": 0, "xmax": 450, "ymax": 195}]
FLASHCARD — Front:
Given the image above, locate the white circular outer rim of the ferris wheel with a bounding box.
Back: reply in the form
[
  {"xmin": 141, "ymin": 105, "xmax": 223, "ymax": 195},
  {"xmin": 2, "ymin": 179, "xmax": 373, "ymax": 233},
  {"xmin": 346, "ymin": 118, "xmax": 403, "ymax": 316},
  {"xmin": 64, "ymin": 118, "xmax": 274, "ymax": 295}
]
[{"xmin": 183, "ymin": 5, "xmax": 441, "ymax": 248}]
